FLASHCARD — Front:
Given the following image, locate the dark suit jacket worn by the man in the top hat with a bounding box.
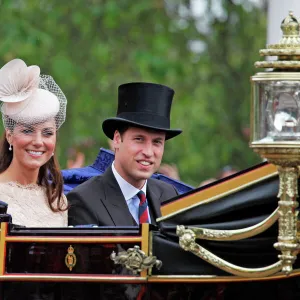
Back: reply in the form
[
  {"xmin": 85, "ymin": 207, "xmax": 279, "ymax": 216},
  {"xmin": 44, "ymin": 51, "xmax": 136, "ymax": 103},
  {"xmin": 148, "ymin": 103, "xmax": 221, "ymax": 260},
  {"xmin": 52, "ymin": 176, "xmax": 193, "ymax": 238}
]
[{"xmin": 67, "ymin": 167, "xmax": 178, "ymax": 226}]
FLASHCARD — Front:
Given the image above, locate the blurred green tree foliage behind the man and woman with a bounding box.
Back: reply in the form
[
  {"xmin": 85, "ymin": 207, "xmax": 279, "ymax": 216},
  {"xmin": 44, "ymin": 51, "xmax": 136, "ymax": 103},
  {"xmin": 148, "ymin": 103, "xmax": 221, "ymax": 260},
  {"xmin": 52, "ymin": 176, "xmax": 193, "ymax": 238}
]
[{"xmin": 0, "ymin": 0, "xmax": 266, "ymax": 185}]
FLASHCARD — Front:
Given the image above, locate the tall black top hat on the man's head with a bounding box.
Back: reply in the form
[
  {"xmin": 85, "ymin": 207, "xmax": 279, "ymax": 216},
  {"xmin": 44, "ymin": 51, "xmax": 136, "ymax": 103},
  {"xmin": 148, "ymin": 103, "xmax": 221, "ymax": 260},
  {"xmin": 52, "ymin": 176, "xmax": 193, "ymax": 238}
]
[{"xmin": 102, "ymin": 82, "xmax": 182, "ymax": 140}]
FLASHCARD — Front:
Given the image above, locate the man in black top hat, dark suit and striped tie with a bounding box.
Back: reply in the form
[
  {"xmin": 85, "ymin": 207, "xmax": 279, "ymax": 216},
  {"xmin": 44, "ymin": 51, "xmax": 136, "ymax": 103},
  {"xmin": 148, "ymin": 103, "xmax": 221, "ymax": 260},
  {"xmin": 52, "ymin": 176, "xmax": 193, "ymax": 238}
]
[{"xmin": 67, "ymin": 82, "xmax": 182, "ymax": 226}]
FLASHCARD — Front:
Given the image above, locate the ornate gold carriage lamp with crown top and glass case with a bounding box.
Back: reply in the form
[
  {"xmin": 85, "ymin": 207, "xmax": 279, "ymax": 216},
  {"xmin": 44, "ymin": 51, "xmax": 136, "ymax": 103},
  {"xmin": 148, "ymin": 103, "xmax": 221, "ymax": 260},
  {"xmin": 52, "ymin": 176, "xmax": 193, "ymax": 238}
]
[{"xmin": 250, "ymin": 12, "xmax": 300, "ymax": 274}]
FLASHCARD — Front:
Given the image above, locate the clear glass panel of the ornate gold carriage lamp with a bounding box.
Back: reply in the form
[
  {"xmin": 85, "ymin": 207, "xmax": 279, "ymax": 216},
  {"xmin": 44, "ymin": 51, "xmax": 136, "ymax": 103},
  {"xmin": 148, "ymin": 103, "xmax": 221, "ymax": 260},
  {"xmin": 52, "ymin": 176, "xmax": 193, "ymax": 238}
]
[{"xmin": 252, "ymin": 80, "xmax": 300, "ymax": 144}]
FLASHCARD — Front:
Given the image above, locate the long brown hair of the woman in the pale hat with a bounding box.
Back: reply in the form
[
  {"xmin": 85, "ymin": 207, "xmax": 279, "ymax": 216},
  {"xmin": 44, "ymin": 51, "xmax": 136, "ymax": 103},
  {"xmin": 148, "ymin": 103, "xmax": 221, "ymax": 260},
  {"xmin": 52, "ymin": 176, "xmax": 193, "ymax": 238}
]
[{"xmin": 0, "ymin": 132, "xmax": 67, "ymax": 212}]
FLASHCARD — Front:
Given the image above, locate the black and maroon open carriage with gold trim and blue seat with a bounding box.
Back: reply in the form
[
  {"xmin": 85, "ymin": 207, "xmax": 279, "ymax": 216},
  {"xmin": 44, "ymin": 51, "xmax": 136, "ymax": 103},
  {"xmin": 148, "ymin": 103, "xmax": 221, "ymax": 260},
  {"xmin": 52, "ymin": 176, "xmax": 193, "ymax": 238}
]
[{"xmin": 0, "ymin": 149, "xmax": 300, "ymax": 300}]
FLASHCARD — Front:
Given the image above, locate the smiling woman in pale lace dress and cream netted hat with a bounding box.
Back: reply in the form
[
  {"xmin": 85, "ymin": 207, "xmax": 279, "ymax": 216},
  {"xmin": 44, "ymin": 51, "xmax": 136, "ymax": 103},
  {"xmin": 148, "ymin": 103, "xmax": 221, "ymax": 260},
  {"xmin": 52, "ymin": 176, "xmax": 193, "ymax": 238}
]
[{"xmin": 0, "ymin": 59, "xmax": 67, "ymax": 227}]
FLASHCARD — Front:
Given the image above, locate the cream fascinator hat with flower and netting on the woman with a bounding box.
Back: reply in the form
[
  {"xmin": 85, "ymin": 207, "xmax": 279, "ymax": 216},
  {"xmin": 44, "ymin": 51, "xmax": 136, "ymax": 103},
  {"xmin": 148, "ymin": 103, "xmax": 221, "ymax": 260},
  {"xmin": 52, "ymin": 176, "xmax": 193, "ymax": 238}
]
[{"xmin": 0, "ymin": 59, "xmax": 67, "ymax": 131}]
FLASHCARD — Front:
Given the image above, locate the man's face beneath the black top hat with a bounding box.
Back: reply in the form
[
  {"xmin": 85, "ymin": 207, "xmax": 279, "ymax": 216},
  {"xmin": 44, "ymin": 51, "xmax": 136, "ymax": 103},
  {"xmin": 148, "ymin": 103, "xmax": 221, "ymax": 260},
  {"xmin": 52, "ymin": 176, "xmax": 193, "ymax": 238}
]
[{"xmin": 113, "ymin": 127, "xmax": 166, "ymax": 189}]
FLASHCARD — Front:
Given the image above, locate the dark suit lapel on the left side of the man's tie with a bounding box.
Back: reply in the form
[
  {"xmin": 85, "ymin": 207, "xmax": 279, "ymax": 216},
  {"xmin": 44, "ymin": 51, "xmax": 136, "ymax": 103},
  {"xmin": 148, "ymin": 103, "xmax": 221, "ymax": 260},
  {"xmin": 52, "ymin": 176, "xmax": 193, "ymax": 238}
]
[{"xmin": 101, "ymin": 167, "xmax": 134, "ymax": 226}]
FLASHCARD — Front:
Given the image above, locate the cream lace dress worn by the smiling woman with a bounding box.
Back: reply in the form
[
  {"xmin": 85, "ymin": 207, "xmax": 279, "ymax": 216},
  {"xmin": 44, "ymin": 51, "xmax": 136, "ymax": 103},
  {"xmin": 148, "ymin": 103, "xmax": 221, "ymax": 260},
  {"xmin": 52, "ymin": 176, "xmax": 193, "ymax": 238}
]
[{"xmin": 0, "ymin": 182, "xmax": 68, "ymax": 227}]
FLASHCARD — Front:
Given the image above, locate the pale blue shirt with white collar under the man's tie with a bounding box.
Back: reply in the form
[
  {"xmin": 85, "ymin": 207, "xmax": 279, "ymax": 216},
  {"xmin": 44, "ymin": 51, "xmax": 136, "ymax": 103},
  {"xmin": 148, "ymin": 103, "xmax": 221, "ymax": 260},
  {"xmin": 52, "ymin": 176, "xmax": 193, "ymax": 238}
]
[{"xmin": 111, "ymin": 162, "xmax": 151, "ymax": 224}]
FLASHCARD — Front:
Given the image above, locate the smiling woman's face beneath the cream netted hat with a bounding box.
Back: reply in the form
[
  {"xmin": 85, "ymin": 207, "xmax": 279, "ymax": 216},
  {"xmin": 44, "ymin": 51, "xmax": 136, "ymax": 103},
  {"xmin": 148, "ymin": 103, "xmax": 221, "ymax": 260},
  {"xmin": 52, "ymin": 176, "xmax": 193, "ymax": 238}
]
[{"xmin": 6, "ymin": 121, "xmax": 56, "ymax": 169}]
